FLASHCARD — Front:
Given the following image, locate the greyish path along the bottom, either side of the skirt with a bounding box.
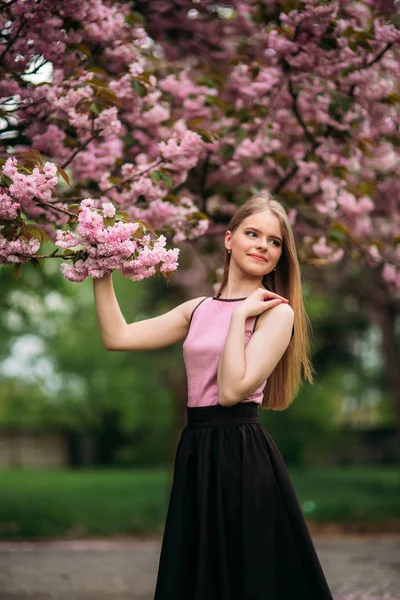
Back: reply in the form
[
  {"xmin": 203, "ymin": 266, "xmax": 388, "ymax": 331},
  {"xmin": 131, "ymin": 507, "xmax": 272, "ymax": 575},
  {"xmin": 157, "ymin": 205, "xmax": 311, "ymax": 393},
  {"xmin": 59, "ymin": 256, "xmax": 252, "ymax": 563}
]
[{"xmin": 0, "ymin": 535, "xmax": 400, "ymax": 600}]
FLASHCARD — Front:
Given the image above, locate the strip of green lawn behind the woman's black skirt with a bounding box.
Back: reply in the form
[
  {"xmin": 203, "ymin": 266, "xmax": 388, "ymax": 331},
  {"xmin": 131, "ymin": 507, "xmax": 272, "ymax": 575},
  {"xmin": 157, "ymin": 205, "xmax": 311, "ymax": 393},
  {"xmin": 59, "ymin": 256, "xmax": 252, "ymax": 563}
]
[{"xmin": 0, "ymin": 467, "xmax": 400, "ymax": 539}]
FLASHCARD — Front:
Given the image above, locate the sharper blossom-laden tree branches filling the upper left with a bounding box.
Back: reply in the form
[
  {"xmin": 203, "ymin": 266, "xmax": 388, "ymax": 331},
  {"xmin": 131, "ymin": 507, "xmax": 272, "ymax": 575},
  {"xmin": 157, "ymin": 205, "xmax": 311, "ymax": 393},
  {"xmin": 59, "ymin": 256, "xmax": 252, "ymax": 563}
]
[{"xmin": 0, "ymin": 0, "xmax": 212, "ymax": 281}]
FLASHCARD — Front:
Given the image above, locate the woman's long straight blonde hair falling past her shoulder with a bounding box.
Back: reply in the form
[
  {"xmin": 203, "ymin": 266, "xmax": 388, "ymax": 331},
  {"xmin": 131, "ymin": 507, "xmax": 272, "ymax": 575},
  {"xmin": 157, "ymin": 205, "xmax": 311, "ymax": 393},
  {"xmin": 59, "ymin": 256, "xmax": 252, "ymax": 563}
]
[{"xmin": 217, "ymin": 193, "xmax": 314, "ymax": 410}]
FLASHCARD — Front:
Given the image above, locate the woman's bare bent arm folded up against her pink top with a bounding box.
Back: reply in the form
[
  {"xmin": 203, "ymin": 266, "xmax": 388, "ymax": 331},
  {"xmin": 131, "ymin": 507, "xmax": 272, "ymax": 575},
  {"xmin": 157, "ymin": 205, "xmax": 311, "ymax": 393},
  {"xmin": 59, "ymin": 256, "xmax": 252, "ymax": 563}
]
[{"xmin": 218, "ymin": 303, "xmax": 294, "ymax": 406}]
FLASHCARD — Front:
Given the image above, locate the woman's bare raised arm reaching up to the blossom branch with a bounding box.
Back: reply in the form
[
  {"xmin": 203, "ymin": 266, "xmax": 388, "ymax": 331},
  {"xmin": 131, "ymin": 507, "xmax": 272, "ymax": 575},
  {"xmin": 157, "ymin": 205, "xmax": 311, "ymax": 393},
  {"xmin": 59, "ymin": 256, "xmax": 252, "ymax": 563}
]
[{"xmin": 93, "ymin": 274, "xmax": 208, "ymax": 351}]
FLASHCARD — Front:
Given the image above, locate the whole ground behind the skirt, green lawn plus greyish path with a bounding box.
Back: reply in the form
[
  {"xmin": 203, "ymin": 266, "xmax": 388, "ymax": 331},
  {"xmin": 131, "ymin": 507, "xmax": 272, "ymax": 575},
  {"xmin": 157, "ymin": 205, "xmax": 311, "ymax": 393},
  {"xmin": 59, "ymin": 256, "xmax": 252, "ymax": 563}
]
[{"xmin": 0, "ymin": 467, "xmax": 400, "ymax": 600}]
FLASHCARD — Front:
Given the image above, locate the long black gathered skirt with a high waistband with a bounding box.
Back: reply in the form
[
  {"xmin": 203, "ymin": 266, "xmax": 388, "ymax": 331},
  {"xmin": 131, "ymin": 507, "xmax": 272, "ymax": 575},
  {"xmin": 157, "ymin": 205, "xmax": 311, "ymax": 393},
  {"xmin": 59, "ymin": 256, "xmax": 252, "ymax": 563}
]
[{"xmin": 154, "ymin": 402, "xmax": 333, "ymax": 600}]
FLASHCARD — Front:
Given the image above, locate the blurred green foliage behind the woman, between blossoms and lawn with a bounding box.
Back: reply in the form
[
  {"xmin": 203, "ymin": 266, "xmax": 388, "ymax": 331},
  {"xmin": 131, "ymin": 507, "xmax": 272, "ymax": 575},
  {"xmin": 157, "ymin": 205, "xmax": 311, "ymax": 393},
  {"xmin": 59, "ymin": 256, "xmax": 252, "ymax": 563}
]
[{"xmin": 0, "ymin": 261, "xmax": 393, "ymax": 466}]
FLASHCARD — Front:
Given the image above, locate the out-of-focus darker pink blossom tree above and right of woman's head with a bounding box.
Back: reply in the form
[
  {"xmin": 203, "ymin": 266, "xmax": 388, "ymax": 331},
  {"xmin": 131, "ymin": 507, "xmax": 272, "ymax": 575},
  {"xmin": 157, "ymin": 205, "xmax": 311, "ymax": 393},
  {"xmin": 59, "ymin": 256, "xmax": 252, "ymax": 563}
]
[{"xmin": 136, "ymin": 0, "xmax": 400, "ymax": 440}]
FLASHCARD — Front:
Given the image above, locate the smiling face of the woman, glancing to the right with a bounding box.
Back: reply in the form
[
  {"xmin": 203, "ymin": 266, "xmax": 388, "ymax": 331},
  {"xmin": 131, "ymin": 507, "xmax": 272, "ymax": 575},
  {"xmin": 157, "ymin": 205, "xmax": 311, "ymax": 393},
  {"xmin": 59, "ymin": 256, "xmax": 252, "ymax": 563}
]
[{"xmin": 225, "ymin": 210, "xmax": 283, "ymax": 277}]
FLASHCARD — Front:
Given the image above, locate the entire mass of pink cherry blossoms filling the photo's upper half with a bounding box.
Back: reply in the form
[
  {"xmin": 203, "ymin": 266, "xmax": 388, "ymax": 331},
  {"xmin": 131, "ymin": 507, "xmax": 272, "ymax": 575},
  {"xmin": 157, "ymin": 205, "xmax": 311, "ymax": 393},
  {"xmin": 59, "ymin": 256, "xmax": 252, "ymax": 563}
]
[{"xmin": 0, "ymin": 0, "xmax": 400, "ymax": 432}]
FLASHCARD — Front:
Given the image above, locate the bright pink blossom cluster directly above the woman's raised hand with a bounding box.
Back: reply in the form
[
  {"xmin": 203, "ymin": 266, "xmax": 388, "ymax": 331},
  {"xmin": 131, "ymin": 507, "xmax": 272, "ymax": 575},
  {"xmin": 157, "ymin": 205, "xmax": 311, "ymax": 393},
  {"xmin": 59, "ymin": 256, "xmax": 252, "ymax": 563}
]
[{"xmin": 55, "ymin": 198, "xmax": 179, "ymax": 282}]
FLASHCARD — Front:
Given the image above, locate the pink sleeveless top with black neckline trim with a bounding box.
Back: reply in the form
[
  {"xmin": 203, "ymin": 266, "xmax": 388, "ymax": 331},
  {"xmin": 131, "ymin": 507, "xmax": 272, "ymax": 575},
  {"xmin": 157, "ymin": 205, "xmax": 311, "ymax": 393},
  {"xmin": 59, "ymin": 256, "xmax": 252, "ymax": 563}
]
[{"xmin": 183, "ymin": 297, "xmax": 267, "ymax": 407}]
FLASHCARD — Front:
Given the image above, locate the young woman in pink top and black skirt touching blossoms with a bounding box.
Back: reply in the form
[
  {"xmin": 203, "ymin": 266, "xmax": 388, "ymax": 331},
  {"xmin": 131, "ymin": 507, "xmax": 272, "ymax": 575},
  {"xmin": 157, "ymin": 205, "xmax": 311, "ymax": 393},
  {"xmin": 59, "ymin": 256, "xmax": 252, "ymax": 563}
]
[{"xmin": 94, "ymin": 195, "xmax": 332, "ymax": 600}]
